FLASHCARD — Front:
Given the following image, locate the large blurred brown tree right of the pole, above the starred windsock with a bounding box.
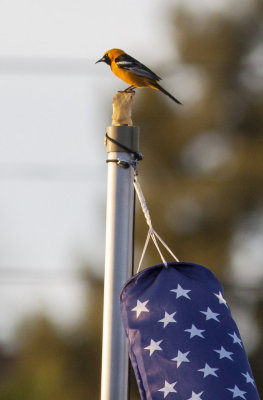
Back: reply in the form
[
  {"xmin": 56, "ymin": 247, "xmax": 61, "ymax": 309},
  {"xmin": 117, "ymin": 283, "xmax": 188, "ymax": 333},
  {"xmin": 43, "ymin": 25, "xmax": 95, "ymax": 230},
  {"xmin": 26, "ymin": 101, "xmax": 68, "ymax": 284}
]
[{"xmin": 134, "ymin": 2, "xmax": 263, "ymax": 279}]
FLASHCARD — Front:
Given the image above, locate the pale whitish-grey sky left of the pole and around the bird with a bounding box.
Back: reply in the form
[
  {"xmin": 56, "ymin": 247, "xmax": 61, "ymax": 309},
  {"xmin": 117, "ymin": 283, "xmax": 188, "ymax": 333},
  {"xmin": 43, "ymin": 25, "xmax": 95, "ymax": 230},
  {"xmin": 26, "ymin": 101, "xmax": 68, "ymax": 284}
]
[{"xmin": 0, "ymin": 0, "xmax": 258, "ymax": 342}]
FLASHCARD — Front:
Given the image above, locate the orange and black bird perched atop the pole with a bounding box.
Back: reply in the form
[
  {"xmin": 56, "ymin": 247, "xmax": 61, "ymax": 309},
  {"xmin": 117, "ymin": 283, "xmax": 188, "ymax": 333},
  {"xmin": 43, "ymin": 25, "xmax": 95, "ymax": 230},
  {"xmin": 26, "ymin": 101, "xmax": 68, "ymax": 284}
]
[{"xmin": 95, "ymin": 49, "xmax": 182, "ymax": 104}]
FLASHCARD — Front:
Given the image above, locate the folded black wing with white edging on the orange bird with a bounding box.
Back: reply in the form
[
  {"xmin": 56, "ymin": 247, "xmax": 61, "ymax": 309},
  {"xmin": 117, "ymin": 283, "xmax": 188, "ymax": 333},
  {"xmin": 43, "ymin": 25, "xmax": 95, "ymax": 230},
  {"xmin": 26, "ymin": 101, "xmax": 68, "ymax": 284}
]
[{"xmin": 115, "ymin": 53, "xmax": 162, "ymax": 81}]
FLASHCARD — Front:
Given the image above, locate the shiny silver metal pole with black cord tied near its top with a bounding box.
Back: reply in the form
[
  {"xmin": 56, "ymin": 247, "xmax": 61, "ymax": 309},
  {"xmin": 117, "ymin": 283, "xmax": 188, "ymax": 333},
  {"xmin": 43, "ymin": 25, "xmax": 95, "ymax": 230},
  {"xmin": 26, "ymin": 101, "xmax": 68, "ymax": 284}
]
[{"xmin": 101, "ymin": 126, "xmax": 139, "ymax": 400}]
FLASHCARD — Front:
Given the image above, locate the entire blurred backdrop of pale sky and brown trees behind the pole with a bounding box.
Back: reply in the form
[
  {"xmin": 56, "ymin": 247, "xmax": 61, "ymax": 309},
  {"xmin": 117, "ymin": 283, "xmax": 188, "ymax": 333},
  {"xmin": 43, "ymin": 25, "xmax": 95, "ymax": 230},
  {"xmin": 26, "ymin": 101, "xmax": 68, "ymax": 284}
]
[{"xmin": 0, "ymin": 0, "xmax": 263, "ymax": 400}]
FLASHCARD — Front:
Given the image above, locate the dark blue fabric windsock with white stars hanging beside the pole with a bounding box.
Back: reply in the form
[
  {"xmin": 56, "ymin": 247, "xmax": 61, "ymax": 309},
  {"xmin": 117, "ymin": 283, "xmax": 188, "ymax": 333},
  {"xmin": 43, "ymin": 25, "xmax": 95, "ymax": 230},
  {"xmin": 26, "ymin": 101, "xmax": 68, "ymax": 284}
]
[{"xmin": 121, "ymin": 262, "xmax": 259, "ymax": 400}]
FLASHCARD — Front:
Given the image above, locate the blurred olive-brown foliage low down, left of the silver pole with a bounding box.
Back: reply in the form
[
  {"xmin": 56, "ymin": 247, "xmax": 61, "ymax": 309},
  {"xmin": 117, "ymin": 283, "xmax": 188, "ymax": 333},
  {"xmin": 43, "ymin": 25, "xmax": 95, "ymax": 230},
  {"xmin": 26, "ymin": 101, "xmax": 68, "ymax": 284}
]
[{"xmin": 0, "ymin": 275, "xmax": 103, "ymax": 400}]
